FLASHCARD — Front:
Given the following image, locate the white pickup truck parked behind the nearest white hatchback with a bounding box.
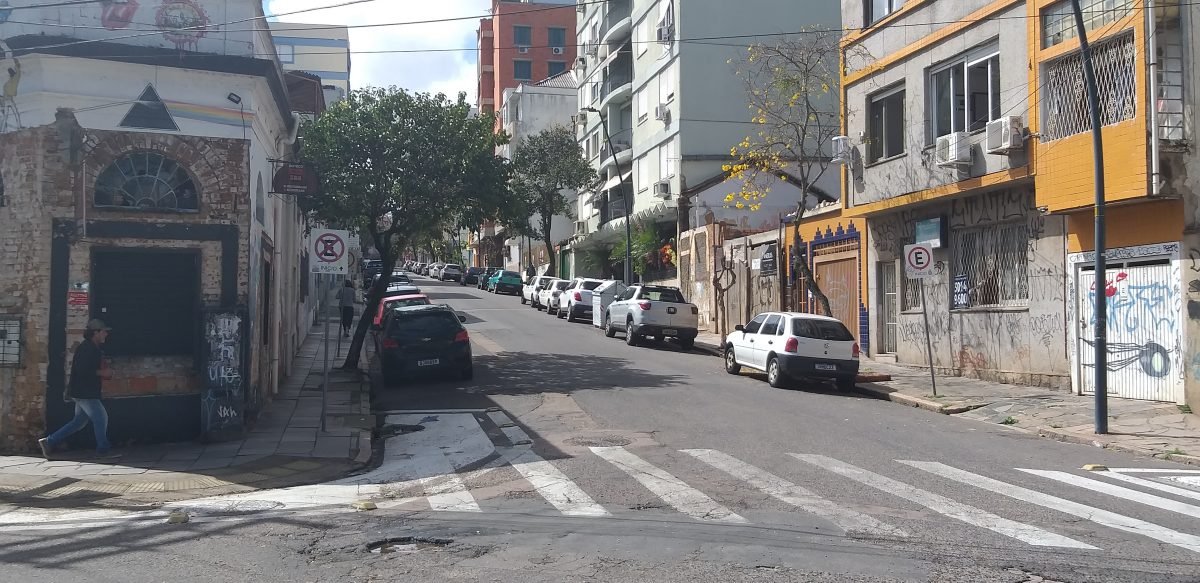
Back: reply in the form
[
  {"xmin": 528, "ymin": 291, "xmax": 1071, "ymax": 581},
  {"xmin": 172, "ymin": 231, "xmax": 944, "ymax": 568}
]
[{"xmin": 604, "ymin": 286, "xmax": 700, "ymax": 350}]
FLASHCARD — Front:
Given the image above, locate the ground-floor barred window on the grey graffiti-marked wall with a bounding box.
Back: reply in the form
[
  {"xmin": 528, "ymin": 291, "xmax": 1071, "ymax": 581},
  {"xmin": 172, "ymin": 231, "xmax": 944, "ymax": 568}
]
[{"xmin": 950, "ymin": 223, "xmax": 1030, "ymax": 306}]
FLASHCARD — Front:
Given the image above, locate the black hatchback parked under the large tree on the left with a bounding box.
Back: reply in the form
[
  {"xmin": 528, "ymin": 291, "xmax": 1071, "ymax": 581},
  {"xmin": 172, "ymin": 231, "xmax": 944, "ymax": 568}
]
[{"xmin": 379, "ymin": 305, "xmax": 475, "ymax": 385}]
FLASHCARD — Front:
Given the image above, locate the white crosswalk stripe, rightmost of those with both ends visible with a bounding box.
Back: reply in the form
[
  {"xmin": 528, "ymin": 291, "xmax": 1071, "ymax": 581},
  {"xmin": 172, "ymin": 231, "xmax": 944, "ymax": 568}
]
[{"xmin": 788, "ymin": 453, "xmax": 1096, "ymax": 548}]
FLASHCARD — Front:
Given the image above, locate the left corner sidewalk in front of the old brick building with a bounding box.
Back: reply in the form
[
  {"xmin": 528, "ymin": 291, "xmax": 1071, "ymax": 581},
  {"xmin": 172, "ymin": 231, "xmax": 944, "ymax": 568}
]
[{"xmin": 0, "ymin": 323, "xmax": 373, "ymax": 506}]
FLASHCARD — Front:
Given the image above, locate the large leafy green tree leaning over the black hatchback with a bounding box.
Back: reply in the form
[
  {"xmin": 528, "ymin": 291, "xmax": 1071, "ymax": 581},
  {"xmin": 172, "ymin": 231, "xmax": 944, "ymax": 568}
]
[{"xmin": 299, "ymin": 88, "xmax": 510, "ymax": 368}]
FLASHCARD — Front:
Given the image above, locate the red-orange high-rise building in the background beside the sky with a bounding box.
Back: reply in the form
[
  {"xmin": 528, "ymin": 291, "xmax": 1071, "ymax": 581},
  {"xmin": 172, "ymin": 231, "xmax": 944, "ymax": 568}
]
[{"xmin": 475, "ymin": 0, "xmax": 576, "ymax": 113}]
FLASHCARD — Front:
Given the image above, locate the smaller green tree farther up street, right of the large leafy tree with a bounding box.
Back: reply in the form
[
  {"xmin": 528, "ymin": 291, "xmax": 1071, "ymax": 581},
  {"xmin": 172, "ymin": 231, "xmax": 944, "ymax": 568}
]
[{"xmin": 512, "ymin": 125, "xmax": 596, "ymax": 274}]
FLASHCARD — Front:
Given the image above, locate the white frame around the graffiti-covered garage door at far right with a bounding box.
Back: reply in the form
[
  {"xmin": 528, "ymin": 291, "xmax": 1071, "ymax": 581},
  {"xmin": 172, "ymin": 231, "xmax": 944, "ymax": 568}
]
[{"xmin": 1067, "ymin": 241, "xmax": 1187, "ymax": 404}]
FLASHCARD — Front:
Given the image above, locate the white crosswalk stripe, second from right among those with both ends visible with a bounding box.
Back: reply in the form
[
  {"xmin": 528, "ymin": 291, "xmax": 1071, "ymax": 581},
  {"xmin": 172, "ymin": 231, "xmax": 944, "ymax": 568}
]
[{"xmin": 682, "ymin": 450, "xmax": 908, "ymax": 536}]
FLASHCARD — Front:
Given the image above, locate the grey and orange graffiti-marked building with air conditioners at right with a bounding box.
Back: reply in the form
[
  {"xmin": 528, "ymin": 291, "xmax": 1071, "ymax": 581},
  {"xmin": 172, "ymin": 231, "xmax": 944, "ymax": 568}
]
[{"xmin": 792, "ymin": 0, "xmax": 1200, "ymax": 405}]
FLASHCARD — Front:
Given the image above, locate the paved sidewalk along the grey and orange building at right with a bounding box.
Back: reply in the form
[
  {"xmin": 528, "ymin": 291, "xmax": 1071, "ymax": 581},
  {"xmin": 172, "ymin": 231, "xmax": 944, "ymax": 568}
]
[{"xmin": 696, "ymin": 333, "xmax": 1200, "ymax": 465}]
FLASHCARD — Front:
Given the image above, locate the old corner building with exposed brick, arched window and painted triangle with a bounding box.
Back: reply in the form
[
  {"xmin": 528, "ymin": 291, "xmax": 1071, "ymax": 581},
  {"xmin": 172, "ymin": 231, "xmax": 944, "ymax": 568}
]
[{"xmin": 0, "ymin": 0, "xmax": 312, "ymax": 449}]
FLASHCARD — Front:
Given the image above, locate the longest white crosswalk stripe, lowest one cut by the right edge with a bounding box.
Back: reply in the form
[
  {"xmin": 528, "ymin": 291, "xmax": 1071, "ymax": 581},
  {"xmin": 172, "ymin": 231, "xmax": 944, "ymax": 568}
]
[{"xmin": 900, "ymin": 461, "xmax": 1200, "ymax": 553}]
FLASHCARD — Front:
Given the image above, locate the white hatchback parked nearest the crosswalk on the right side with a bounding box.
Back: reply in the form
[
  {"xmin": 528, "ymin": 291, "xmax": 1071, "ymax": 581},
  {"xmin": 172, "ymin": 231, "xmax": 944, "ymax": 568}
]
[{"xmin": 725, "ymin": 312, "xmax": 859, "ymax": 390}]
